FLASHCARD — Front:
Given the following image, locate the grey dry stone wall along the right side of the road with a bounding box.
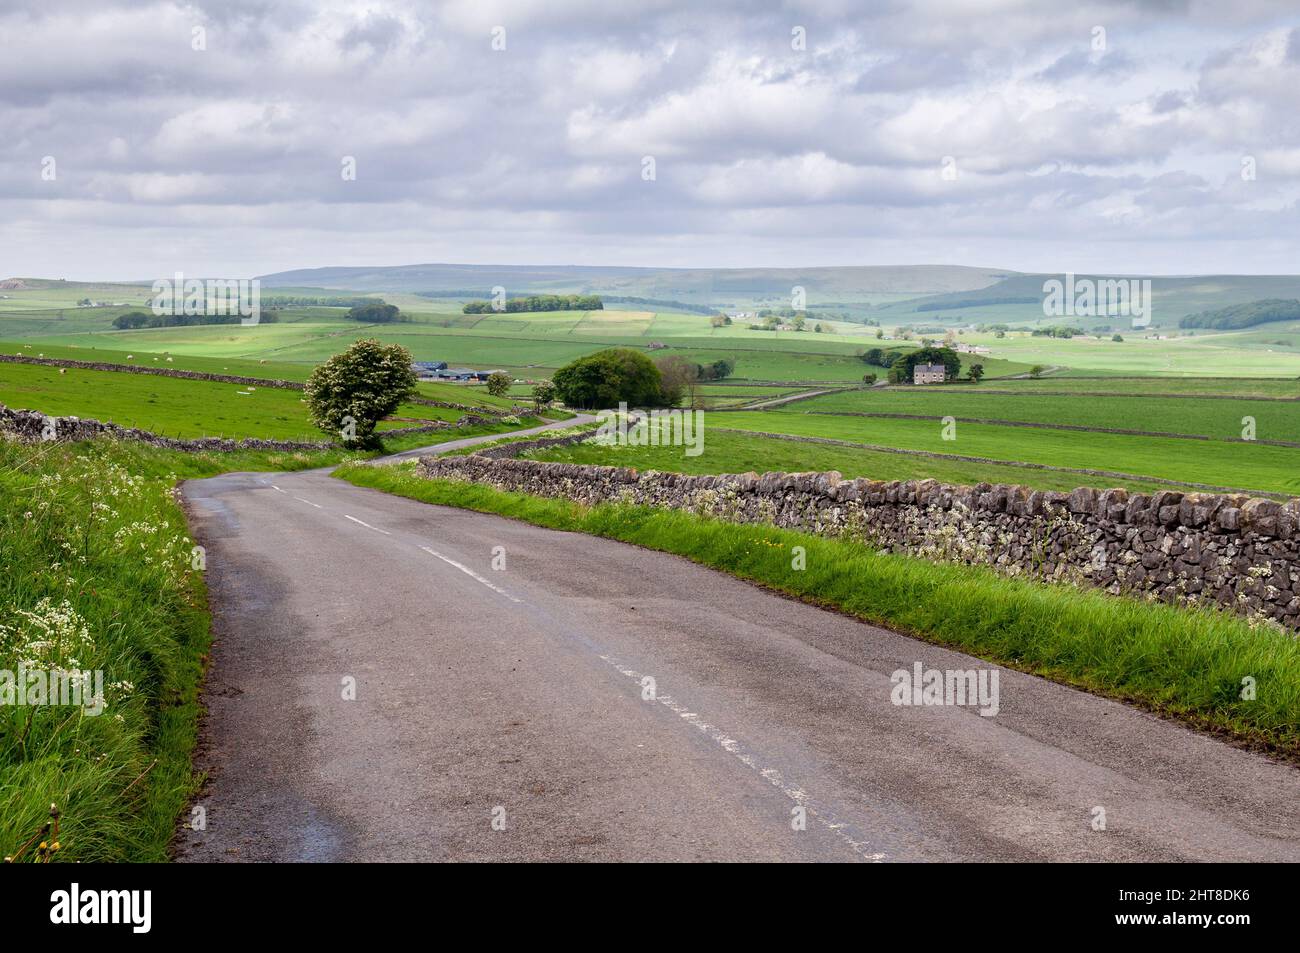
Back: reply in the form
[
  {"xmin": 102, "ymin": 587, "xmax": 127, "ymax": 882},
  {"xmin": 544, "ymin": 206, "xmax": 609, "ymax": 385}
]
[{"xmin": 419, "ymin": 454, "xmax": 1300, "ymax": 629}]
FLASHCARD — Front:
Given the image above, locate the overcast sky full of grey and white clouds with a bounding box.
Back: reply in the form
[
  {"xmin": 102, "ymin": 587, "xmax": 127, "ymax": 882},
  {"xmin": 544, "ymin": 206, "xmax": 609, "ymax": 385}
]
[{"xmin": 0, "ymin": 0, "xmax": 1300, "ymax": 280}]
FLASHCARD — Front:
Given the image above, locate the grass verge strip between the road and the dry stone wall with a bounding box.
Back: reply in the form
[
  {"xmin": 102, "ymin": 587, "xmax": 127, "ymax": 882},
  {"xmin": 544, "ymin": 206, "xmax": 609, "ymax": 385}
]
[{"xmin": 335, "ymin": 464, "xmax": 1300, "ymax": 759}]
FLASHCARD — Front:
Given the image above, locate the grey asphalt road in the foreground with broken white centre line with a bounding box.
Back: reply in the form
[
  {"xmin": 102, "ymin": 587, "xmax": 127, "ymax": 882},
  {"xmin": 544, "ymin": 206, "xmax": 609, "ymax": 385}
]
[{"xmin": 177, "ymin": 421, "xmax": 1300, "ymax": 861}]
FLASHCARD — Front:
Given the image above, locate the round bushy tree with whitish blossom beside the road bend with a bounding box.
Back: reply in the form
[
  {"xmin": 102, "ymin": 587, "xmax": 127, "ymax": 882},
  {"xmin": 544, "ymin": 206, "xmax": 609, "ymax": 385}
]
[{"xmin": 303, "ymin": 338, "xmax": 416, "ymax": 447}]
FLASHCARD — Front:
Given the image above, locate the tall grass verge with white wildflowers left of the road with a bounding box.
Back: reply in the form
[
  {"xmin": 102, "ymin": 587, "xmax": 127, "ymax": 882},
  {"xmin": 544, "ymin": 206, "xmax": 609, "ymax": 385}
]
[{"xmin": 0, "ymin": 441, "xmax": 220, "ymax": 862}]
